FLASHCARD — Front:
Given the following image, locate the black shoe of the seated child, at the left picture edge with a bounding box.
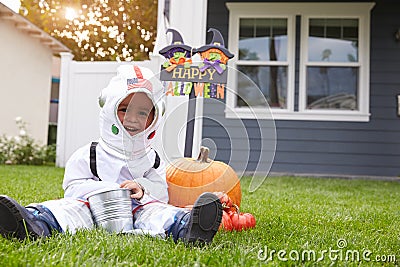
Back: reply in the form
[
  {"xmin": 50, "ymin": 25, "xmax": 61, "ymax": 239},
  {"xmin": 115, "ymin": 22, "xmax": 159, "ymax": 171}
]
[{"xmin": 0, "ymin": 195, "xmax": 51, "ymax": 240}]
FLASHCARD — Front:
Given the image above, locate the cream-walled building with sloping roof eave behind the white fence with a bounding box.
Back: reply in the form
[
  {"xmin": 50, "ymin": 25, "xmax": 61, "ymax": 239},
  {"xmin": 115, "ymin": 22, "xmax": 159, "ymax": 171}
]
[{"xmin": 0, "ymin": 3, "xmax": 70, "ymax": 144}]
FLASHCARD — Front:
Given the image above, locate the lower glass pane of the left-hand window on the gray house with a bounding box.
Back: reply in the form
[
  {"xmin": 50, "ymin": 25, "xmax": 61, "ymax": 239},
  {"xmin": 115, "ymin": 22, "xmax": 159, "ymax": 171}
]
[{"xmin": 237, "ymin": 66, "xmax": 287, "ymax": 108}]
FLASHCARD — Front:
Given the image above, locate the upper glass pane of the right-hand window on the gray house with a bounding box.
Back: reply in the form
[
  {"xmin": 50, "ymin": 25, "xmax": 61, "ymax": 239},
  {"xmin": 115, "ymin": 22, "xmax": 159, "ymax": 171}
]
[{"xmin": 308, "ymin": 19, "xmax": 358, "ymax": 62}]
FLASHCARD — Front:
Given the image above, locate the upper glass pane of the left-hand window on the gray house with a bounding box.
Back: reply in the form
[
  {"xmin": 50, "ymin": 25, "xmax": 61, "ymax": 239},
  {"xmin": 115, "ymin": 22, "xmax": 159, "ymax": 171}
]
[{"xmin": 239, "ymin": 18, "xmax": 287, "ymax": 61}]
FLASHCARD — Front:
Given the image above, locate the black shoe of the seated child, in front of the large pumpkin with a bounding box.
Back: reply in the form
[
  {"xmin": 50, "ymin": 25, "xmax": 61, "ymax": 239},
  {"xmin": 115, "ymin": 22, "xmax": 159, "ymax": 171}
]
[{"xmin": 172, "ymin": 193, "xmax": 222, "ymax": 244}]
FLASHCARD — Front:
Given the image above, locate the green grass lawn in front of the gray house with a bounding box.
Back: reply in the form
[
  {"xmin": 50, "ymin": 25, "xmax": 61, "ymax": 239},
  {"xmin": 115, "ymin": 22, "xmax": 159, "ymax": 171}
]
[{"xmin": 0, "ymin": 166, "xmax": 400, "ymax": 266}]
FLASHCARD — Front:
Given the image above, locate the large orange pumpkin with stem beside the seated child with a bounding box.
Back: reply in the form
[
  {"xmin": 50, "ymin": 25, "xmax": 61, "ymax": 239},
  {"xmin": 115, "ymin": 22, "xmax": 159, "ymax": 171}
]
[{"xmin": 167, "ymin": 147, "xmax": 242, "ymax": 207}]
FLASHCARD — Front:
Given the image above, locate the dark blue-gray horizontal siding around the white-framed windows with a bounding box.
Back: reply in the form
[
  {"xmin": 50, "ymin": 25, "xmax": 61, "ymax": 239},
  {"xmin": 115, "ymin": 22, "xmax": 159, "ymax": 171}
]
[{"xmin": 203, "ymin": 0, "xmax": 400, "ymax": 176}]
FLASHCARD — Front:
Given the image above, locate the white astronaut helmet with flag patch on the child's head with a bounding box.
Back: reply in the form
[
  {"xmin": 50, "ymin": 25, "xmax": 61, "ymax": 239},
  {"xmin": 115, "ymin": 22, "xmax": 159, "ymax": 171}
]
[{"xmin": 99, "ymin": 65, "xmax": 165, "ymax": 160}]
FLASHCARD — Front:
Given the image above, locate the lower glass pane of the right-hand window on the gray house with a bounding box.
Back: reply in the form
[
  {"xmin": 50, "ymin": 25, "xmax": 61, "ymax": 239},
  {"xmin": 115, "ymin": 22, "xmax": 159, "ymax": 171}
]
[{"xmin": 307, "ymin": 67, "xmax": 359, "ymax": 110}]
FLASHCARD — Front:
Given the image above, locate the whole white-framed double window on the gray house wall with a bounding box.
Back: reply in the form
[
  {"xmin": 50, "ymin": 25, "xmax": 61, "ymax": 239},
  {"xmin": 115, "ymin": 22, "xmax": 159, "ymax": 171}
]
[{"xmin": 225, "ymin": 3, "xmax": 373, "ymax": 121}]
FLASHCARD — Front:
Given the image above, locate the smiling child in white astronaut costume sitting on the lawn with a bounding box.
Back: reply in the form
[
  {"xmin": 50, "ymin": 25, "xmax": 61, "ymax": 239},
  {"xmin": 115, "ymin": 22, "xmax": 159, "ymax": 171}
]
[{"xmin": 0, "ymin": 65, "xmax": 222, "ymax": 243}]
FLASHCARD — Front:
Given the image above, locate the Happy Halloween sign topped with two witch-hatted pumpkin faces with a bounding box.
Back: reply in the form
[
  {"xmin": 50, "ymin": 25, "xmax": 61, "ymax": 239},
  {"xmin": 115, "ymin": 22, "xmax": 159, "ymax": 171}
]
[{"xmin": 159, "ymin": 28, "xmax": 234, "ymax": 99}]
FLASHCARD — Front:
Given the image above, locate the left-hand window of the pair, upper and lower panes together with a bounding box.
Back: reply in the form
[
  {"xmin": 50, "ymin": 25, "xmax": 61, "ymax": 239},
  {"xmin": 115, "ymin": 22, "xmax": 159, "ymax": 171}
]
[{"xmin": 236, "ymin": 18, "xmax": 288, "ymax": 108}]
